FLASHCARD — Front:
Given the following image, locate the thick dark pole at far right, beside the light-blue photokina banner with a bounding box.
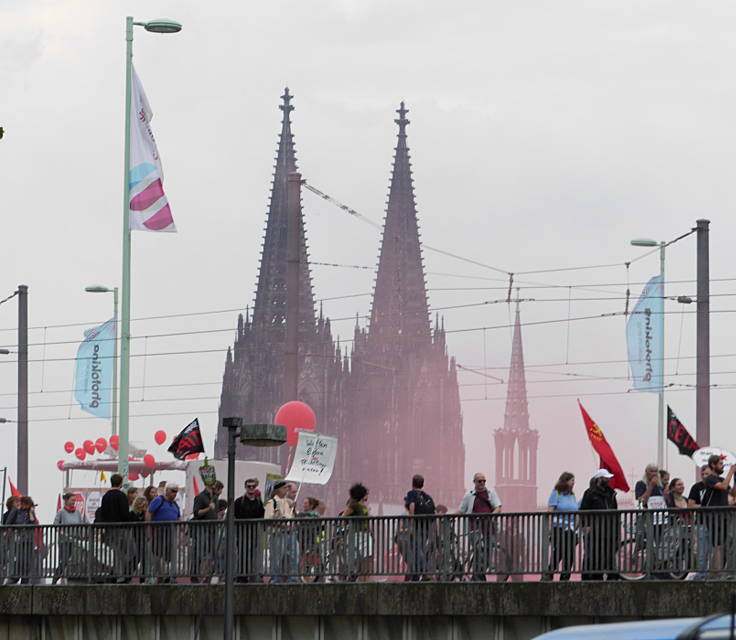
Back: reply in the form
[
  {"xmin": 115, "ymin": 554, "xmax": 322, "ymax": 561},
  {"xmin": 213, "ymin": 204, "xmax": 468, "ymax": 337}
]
[{"xmin": 695, "ymin": 219, "xmax": 710, "ymax": 447}]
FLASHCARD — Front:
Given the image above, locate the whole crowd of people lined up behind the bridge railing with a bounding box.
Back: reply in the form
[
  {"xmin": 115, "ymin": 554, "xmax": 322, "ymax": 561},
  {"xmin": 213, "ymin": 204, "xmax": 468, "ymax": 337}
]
[{"xmin": 0, "ymin": 456, "xmax": 736, "ymax": 584}]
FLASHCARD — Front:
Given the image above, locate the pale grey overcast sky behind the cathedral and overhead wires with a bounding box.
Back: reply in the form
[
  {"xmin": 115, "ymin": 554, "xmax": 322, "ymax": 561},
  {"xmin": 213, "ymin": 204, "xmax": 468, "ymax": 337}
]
[{"xmin": 0, "ymin": 0, "xmax": 736, "ymax": 521}]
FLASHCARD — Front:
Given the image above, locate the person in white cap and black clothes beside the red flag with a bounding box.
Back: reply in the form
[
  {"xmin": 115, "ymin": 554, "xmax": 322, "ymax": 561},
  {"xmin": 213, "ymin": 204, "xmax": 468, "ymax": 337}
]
[{"xmin": 580, "ymin": 469, "xmax": 620, "ymax": 580}]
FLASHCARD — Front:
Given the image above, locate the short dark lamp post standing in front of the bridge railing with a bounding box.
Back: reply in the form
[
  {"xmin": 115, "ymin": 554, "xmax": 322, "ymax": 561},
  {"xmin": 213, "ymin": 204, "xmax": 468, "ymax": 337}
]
[{"xmin": 222, "ymin": 418, "xmax": 286, "ymax": 640}]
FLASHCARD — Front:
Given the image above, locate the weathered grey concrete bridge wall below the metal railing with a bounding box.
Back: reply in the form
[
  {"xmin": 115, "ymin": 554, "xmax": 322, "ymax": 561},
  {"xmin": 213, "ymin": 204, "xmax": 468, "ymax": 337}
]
[{"xmin": 0, "ymin": 581, "xmax": 736, "ymax": 640}]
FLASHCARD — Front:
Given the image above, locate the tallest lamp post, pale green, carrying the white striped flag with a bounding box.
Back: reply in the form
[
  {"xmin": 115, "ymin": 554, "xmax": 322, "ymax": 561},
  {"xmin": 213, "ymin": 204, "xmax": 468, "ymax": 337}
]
[{"xmin": 118, "ymin": 16, "xmax": 181, "ymax": 485}]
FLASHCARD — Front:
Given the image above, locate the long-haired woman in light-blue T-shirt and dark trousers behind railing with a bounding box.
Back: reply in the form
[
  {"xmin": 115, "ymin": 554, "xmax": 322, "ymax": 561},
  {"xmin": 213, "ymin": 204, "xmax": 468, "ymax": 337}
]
[{"xmin": 542, "ymin": 471, "xmax": 578, "ymax": 580}]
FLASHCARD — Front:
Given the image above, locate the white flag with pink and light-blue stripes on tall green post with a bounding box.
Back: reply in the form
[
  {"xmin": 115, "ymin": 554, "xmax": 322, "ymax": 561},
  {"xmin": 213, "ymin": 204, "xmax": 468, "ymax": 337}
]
[{"xmin": 128, "ymin": 69, "xmax": 176, "ymax": 231}]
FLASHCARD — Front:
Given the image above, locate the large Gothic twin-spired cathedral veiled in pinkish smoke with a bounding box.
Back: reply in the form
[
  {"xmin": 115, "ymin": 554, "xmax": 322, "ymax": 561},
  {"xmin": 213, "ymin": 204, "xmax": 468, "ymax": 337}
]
[{"xmin": 215, "ymin": 89, "xmax": 465, "ymax": 514}]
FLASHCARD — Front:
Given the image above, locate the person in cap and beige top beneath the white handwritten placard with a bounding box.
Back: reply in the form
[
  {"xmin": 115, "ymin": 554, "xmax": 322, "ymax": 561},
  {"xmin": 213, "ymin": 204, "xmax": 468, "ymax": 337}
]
[{"xmin": 264, "ymin": 480, "xmax": 299, "ymax": 582}]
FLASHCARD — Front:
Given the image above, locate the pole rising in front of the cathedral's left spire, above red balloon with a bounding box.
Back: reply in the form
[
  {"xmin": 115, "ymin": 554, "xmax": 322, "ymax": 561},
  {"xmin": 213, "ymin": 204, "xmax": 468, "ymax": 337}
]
[{"xmin": 284, "ymin": 173, "xmax": 302, "ymax": 400}]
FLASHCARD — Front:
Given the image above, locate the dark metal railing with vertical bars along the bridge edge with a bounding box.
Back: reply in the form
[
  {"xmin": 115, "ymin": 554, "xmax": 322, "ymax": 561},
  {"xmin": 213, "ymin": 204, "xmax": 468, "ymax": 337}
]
[{"xmin": 0, "ymin": 508, "xmax": 736, "ymax": 584}]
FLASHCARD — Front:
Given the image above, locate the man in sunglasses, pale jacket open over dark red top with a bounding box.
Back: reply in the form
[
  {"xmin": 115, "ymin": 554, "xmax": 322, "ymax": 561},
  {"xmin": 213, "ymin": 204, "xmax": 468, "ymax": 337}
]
[{"xmin": 458, "ymin": 473, "xmax": 502, "ymax": 582}]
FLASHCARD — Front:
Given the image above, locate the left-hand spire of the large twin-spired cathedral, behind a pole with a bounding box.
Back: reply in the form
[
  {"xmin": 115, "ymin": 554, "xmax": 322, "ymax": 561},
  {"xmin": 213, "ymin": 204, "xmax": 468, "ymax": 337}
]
[{"xmin": 253, "ymin": 87, "xmax": 316, "ymax": 326}]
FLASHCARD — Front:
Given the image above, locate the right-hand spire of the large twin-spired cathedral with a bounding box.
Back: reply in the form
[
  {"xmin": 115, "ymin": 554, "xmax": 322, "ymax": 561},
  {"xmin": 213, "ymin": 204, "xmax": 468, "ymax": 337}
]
[{"xmin": 369, "ymin": 102, "xmax": 431, "ymax": 349}]
